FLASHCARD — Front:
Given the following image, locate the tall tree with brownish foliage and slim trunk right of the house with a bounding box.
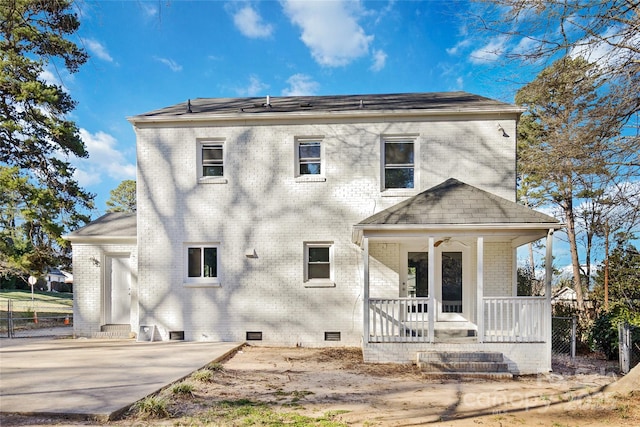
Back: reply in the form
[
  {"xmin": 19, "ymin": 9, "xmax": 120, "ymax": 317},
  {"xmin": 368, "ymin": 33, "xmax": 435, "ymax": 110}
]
[{"xmin": 516, "ymin": 58, "xmax": 625, "ymax": 311}]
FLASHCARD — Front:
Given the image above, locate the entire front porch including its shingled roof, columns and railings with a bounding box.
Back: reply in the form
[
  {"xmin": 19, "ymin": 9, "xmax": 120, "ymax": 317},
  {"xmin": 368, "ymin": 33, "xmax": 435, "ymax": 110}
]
[{"xmin": 353, "ymin": 180, "xmax": 561, "ymax": 374}]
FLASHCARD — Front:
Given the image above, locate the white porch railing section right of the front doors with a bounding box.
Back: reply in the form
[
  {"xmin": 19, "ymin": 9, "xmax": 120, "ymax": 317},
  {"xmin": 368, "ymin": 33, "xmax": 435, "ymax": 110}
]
[{"xmin": 483, "ymin": 297, "xmax": 551, "ymax": 342}]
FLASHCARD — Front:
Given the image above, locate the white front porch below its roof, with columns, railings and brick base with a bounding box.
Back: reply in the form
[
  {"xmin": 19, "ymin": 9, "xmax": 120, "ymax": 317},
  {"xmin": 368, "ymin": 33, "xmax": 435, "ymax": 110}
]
[{"xmin": 363, "ymin": 234, "xmax": 553, "ymax": 374}]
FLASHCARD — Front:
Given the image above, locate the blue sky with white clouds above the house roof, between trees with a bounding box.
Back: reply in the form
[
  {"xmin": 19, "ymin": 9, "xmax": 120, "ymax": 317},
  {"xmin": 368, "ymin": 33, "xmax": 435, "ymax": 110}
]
[{"xmin": 58, "ymin": 0, "xmax": 540, "ymax": 218}]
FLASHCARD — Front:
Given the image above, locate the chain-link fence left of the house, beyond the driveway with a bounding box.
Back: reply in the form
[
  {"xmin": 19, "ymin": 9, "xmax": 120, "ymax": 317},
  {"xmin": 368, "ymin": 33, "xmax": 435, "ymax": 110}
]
[{"xmin": 0, "ymin": 298, "xmax": 73, "ymax": 338}]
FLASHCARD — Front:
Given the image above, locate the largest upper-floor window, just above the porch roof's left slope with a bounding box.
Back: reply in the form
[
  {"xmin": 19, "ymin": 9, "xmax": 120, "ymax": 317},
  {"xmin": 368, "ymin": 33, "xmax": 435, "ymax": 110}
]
[{"xmin": 382, "ymin": 136, "xmax": 417, "ymax": 190}]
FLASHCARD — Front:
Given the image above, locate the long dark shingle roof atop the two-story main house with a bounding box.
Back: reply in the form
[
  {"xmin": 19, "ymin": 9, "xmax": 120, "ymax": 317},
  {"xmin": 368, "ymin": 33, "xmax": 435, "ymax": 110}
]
[{"xmin": 130, "ymin": 92, "xmax": 522, "ymax": 122}]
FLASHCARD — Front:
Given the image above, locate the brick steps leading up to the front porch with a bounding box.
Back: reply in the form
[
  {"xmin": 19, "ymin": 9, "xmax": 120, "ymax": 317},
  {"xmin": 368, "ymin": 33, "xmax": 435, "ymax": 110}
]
[{"xmin": 417, "ymin": 351, "xmax": 513, "ymax": 379}]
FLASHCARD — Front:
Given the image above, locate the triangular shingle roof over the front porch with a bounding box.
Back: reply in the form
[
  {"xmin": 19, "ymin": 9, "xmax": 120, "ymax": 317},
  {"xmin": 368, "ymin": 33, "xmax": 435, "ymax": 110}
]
[{"xmin": 358, "ymin": 178, "xmax": 559, "ymax": 225}]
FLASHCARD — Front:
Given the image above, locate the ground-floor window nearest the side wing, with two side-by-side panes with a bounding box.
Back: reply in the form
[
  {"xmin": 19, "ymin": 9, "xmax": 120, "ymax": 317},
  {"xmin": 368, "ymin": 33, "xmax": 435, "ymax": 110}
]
[{"xmin": 185, "ymin": 244, "xmax": 220, "ymax": 285}]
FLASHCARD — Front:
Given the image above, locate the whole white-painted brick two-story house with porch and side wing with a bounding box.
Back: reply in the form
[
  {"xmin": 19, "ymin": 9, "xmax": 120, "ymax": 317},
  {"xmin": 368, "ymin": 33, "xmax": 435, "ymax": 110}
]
[{"xmin": 67, "ymin": 92, "xmax": 561, "ymax": 373}]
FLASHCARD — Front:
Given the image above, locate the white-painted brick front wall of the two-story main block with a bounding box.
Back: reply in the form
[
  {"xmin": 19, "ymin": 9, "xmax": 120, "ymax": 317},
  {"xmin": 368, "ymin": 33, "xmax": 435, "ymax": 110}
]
[{"xmin": 137, "ymin": 117, "xmax": 515, "ymax": 346}]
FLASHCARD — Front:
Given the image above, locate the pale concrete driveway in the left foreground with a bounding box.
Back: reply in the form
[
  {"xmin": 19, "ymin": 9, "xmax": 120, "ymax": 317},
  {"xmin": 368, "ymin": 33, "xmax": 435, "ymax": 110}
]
[{"xmin": 0, "ymin": 338, "xmax": 242, "ymax": 425}]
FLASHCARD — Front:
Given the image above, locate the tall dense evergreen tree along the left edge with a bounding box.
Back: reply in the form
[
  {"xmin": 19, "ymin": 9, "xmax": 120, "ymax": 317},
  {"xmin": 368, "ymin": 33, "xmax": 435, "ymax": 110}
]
[{"xmin": 0, "ymin": 0, "xmax": 93, "ymax": 274}]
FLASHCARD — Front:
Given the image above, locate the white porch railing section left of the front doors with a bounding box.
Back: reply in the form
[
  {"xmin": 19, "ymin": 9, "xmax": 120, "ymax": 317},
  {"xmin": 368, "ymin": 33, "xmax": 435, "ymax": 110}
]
[{"xmin": 369, "ymin": 298, "xmax": 430, "ymax": 342}]
